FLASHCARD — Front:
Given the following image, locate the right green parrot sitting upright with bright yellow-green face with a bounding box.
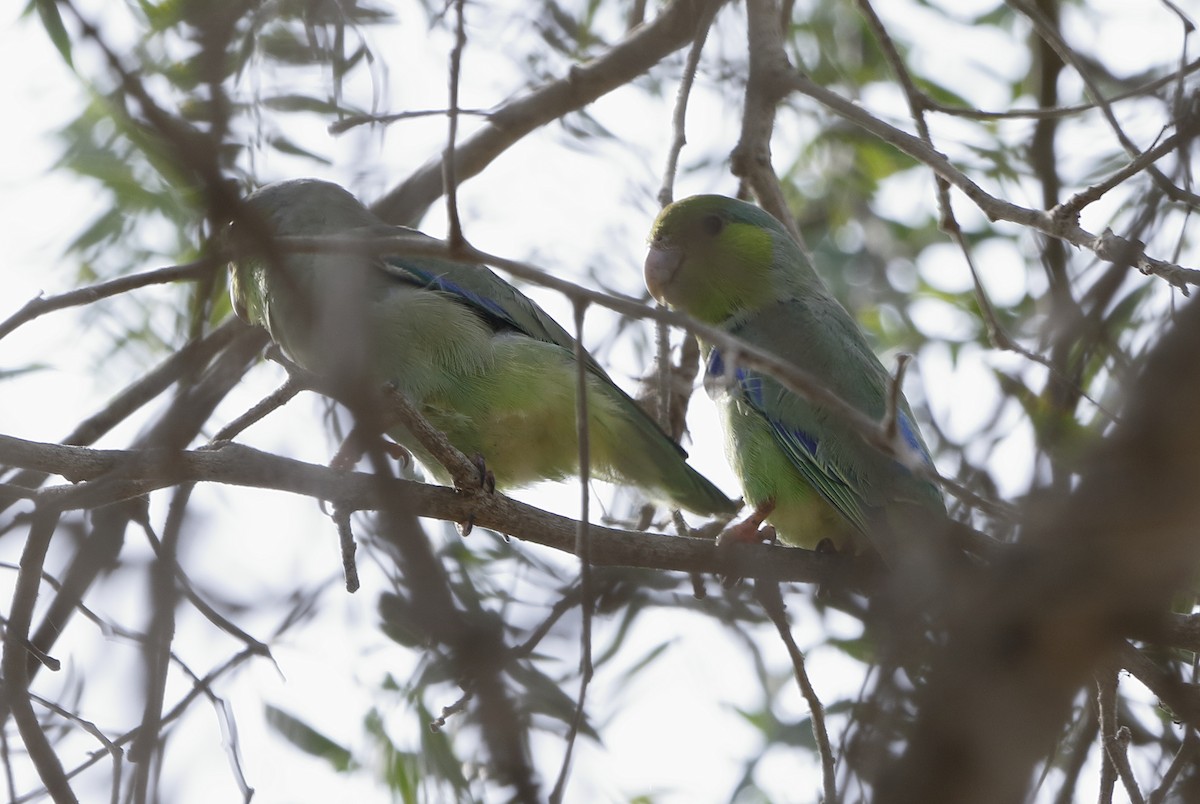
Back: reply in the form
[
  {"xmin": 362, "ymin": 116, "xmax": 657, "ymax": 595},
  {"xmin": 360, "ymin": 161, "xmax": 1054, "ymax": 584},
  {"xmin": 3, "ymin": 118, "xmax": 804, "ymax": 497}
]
[{"xmin": 646, "ymin": 196, "xmax": 946, "ymax": 563}]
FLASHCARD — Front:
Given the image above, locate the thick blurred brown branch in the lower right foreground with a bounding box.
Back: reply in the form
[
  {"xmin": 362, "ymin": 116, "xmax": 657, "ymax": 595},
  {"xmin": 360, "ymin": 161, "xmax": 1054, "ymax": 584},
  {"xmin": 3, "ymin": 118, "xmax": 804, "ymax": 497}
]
[{"xmin": 875, "ymin": 286, "xmax": 1200, "ymax": 804}]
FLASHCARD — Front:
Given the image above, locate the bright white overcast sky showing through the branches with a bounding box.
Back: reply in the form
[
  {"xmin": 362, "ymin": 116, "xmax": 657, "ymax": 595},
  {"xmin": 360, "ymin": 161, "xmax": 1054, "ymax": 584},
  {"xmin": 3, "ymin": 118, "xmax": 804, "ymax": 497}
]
[{"xmin": 0, "ymin": 0, "xmax": 1195, "ymax": 803}]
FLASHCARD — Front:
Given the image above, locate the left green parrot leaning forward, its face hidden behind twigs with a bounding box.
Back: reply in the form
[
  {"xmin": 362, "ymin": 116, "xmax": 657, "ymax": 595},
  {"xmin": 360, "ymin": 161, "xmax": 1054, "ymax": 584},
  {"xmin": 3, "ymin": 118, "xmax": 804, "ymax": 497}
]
[{"xmin": 230, "ymin": 179, "xmax": 739, "ymax": 516}]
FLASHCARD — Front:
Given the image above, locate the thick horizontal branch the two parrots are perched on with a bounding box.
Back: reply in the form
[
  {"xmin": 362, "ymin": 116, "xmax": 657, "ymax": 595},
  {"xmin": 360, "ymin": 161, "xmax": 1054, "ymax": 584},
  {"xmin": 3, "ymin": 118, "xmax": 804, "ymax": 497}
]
[{"xmin": 0, "ymin": 436, "xmax": 866, "ymax": 584}]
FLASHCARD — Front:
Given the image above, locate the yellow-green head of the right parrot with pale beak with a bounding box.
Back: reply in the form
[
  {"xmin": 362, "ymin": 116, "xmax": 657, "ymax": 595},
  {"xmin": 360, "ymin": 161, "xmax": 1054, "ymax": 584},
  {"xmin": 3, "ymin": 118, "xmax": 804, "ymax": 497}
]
[{"xmin": 646, "ymin": 196, "xmax": 794, "ymax": 324}]
